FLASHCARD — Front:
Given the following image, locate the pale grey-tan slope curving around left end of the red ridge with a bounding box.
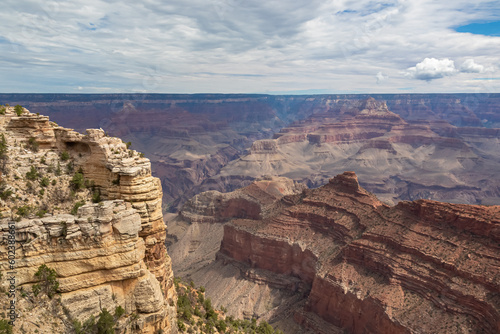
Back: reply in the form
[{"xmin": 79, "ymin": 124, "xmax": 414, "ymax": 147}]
[{"xmin": 167, "ymin": 177, "xmax": 305, "ymax": 333}]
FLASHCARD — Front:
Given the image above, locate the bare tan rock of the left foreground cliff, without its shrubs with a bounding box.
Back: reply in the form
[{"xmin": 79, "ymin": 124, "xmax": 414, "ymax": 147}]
[{"xmin": 0, "ymin": 108, "xmax": 176, "ymax": 333}]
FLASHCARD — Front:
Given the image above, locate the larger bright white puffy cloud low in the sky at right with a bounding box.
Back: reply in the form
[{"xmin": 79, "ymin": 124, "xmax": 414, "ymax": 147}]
[{"xmin": 405, "ymin": 58, "xmax": 457, "ymax": 81}]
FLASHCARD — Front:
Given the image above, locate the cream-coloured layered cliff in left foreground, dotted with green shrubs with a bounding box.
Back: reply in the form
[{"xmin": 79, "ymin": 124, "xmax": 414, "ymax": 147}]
[{"xmin": 0, "ymin": 107, "xmax": 177, "ymax": 333}]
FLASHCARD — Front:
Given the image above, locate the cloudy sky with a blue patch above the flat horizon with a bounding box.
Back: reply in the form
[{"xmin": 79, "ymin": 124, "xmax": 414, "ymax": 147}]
[{"xmin": 0, "ymin": 0, "xmax": 500, "ymax": 94}]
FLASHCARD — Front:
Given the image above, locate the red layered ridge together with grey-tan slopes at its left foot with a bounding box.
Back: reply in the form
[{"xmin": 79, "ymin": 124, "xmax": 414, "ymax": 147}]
[{"xmin": 171, "ymin": 172, "xmax": 500, "ymax": 333}]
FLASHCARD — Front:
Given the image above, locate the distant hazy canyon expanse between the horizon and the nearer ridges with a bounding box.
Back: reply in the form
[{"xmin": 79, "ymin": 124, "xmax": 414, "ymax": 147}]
[{"xmin": 0, "ymin": 94, "xmax": 500, "ymax": 212}]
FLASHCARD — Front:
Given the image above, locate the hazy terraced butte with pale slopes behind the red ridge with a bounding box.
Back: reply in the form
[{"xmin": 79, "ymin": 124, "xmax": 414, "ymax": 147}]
[{"xmin": 219, "ymin": 98, "xmax": 500, "ymax": 205}]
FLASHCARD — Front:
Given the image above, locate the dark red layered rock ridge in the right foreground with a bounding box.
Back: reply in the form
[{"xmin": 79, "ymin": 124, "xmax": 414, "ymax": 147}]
[{"xmin": 220, "ymin": 172, "xmax": 500, "ymax": 333}]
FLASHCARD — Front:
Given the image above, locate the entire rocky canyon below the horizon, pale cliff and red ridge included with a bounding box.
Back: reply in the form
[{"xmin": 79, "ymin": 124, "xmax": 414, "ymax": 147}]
[{"xmin": 0, "ymin": 94, "xmax": 500, "ymax": 333}]
